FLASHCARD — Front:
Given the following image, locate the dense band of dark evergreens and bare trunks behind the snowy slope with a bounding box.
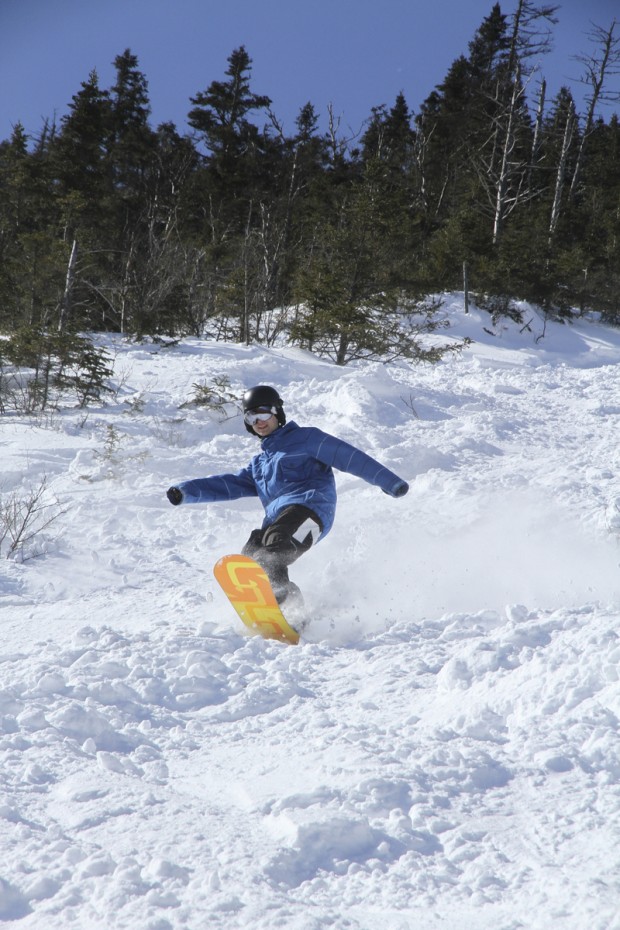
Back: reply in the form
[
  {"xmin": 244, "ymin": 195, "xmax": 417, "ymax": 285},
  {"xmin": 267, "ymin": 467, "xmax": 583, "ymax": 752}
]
[{"xmin": 0, "ymin": 0, "xmax": 620, "ymax": 374}]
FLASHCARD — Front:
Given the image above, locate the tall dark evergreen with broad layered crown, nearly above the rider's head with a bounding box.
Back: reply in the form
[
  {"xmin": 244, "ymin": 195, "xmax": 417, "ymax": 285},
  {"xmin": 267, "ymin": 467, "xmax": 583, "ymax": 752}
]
[{"xmin": 184, "ymin": 46, "xmax": 284, "ymax": 340}]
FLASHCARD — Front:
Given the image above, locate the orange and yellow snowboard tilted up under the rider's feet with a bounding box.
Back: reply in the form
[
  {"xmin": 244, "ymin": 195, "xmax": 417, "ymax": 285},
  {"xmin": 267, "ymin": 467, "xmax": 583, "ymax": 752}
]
[{"xmin": 213, "ymin": 555, "xmax": 299, "ymax": 643}]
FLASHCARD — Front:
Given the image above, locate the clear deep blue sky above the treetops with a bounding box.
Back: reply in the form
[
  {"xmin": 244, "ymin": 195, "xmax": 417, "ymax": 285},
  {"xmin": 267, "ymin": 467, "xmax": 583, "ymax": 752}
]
[{"xmin": 0, "ymin": 0, "xmax": 620, "ymax": 139}]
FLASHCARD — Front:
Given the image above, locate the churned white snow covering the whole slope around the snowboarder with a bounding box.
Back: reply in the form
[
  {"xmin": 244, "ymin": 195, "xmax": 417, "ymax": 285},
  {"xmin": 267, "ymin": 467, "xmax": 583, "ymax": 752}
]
[{"xmin": 0, "ymin": 295, "xmax": 620, "ymax": 930}]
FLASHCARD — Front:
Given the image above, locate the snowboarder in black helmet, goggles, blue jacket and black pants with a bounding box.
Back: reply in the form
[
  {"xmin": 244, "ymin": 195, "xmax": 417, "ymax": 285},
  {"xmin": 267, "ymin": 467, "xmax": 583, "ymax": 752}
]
[{"xmin": 167, "ymin": 385, "xmax": 409, "ymax": 604}]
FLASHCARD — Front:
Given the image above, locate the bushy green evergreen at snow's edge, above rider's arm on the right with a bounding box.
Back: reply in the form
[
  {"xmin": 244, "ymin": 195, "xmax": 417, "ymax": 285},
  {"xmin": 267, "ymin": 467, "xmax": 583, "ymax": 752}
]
[{"xmin": 291, "ymin": 151, "xmax": 440, "ymax": 365}]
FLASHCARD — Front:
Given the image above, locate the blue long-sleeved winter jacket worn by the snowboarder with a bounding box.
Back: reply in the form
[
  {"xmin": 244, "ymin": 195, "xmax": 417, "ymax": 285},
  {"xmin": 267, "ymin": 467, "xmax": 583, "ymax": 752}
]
[{"xmin": 177, "ymin": 421, "xmax": 407, "ymax": 536}]
